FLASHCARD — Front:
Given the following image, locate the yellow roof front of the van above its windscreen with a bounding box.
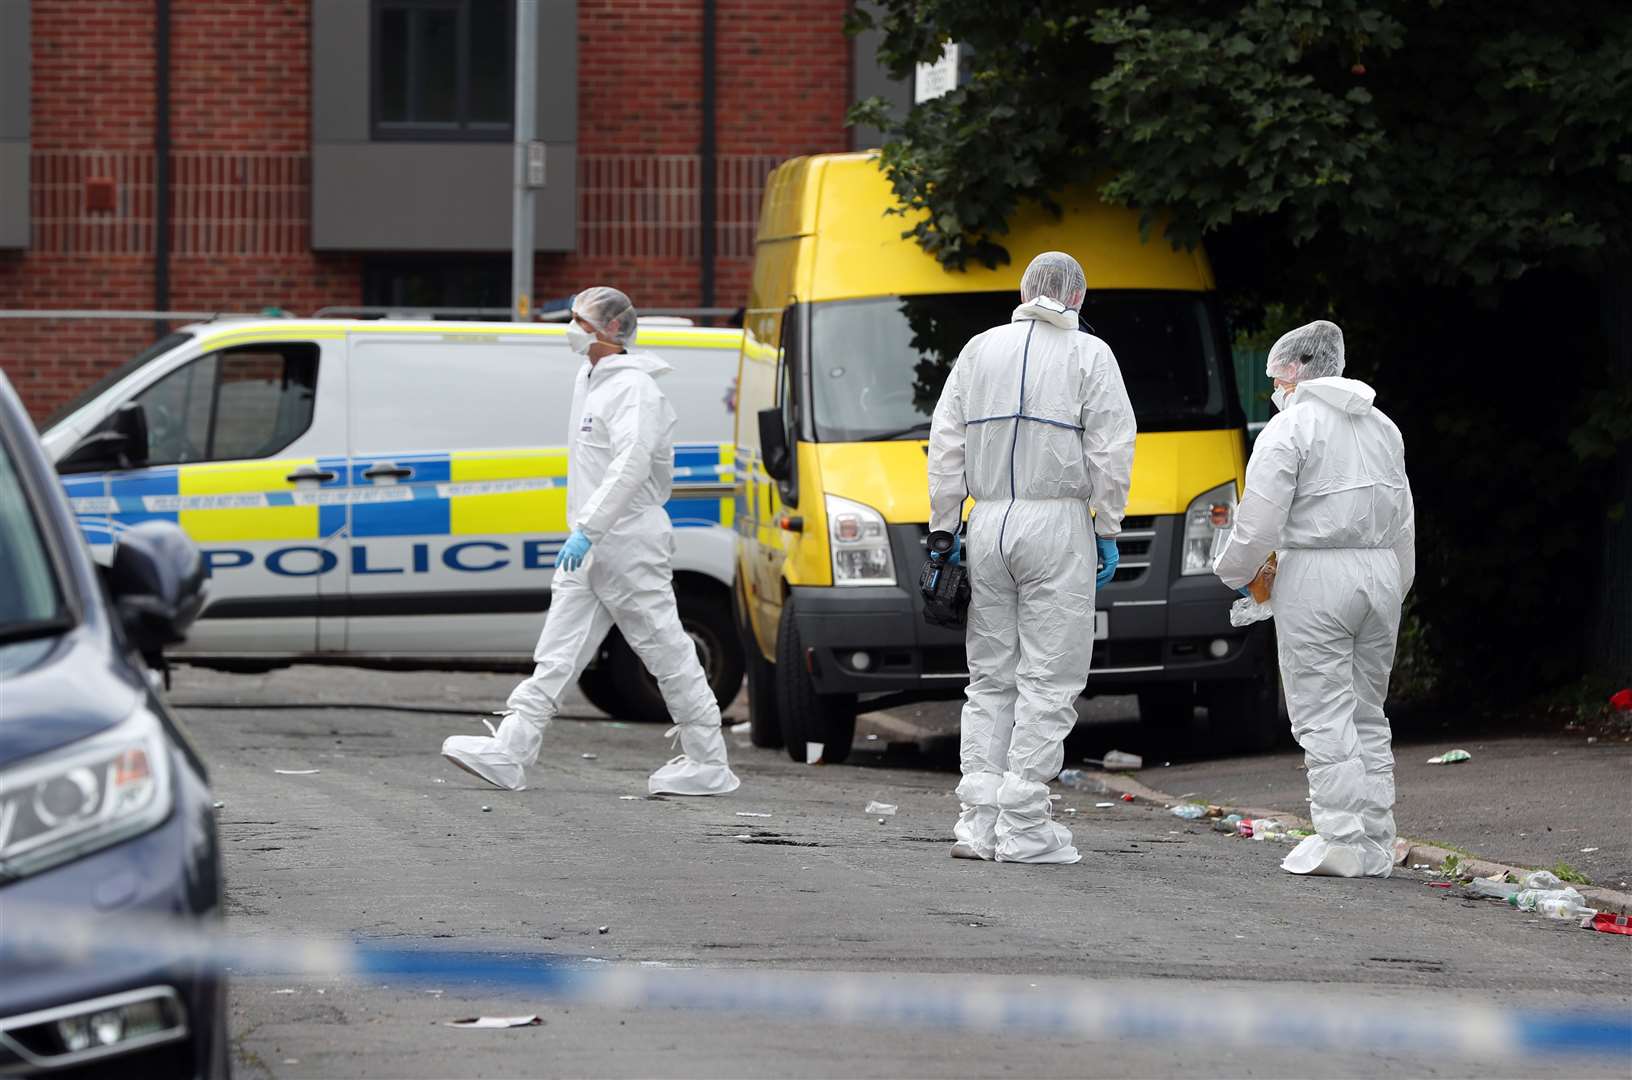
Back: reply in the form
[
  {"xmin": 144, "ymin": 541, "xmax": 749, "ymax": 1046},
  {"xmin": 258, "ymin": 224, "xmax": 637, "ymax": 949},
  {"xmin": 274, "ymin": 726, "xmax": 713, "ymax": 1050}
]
[{"xmin": 759, "ymin": 152, "xmax": 1213, "ymax": 300}]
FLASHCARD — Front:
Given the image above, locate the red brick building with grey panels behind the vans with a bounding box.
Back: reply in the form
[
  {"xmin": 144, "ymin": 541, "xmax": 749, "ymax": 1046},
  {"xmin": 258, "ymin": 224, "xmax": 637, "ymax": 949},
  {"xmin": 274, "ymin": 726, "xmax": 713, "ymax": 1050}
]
[{"xmin": 0, "ymin": 0, "xmax": 896, "ymax": 418}]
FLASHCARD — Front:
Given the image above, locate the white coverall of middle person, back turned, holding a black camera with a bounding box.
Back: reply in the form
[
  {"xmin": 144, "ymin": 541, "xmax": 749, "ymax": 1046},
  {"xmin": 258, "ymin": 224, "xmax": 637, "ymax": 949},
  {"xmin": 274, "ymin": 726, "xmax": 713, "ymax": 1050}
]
[{"xmin": 929, "ymin": 293, "xmax": 1134, "ymax": 863}]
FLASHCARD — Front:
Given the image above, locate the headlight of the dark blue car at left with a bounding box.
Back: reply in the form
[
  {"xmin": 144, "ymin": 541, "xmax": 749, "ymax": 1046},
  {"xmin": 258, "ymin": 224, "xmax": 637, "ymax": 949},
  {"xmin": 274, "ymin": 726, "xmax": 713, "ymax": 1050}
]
[{"xmin": 0, "ymin": 708, "xmax": 171, "ymax": 879}]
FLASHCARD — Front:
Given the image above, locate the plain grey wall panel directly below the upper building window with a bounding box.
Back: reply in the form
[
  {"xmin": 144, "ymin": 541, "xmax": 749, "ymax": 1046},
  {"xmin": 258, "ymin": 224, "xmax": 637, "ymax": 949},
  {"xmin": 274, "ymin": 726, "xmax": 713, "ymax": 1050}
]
[{"xmin": 312, "ymin": 142, "xmax": 578, "ymax": 251}]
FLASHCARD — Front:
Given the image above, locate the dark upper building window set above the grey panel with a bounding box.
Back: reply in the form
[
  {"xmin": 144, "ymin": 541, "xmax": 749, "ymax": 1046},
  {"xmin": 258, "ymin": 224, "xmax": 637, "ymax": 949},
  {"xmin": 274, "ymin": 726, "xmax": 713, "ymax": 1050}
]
[{"xmin": 372, "ymin": 0, "xmax": 516, "ymax": 142}]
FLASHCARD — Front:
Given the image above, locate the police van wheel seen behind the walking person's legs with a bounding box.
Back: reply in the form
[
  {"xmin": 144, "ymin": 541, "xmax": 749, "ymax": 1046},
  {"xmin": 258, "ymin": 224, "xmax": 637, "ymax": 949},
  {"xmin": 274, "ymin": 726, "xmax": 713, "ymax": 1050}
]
[{"xmin": 578, "ymin": 589, "xmax": 743, "ymax": 724}]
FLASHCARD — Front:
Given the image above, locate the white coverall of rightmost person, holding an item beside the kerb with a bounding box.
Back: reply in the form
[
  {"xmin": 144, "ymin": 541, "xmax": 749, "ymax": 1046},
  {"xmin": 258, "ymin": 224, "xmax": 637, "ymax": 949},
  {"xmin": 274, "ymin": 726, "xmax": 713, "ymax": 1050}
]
[{"xmin": 1214, "ymin": 371, "xmax": 1417, "ymax": 878}]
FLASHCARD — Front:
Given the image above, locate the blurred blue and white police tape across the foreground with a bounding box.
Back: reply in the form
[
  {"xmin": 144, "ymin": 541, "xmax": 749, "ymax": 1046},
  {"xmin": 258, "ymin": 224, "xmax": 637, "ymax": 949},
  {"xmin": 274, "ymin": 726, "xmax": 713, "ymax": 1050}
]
[{"xmin": 0, "ymin": 909, "xmax": 1632, "ymax": 1065}]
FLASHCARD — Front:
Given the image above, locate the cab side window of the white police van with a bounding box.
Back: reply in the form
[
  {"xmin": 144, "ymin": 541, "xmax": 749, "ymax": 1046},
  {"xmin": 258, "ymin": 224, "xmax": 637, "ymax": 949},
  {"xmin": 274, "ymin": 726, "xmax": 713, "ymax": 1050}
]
[{"xmin": 135, "ymin": 343, "xmax": 318, "ymax": 465}]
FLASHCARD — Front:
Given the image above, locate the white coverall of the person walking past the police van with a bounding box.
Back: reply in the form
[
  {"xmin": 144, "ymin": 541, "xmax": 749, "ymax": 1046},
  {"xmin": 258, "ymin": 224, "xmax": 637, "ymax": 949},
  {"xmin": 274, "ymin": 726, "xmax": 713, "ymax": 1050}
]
[{"xmin": 442, "ymin": 352, "xmax": 741, "ymax": 795}]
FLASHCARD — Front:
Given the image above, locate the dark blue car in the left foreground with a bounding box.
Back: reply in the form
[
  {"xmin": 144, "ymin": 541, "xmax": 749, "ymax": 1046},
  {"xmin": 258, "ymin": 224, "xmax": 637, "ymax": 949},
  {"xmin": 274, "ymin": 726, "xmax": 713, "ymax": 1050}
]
[{"xmin": 0, "ymin": 374, "xmax": 230, "ymax": 1077}]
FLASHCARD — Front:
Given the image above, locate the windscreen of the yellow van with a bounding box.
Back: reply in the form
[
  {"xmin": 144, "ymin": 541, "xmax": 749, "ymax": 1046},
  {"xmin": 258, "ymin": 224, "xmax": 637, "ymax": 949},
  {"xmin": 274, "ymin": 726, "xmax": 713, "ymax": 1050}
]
[{"xmin": 808, "ymin": 290, "xmax": 1239, "ymax": 442}]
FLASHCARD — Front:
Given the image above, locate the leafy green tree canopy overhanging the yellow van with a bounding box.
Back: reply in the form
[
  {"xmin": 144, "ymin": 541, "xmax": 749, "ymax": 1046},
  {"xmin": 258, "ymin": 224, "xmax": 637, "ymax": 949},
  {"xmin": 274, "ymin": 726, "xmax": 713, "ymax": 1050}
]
[{"xmin": 855, "ymin": 0, "xmax": 1632, "ymax": 292}]
